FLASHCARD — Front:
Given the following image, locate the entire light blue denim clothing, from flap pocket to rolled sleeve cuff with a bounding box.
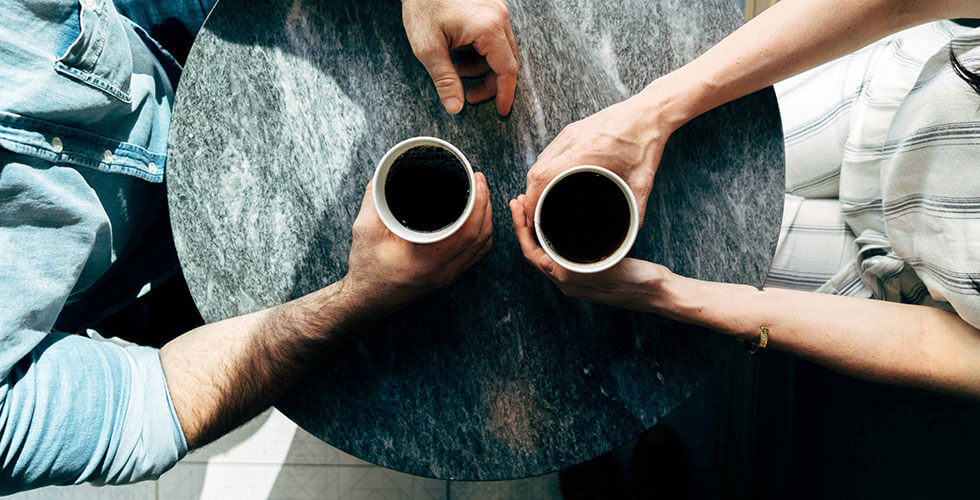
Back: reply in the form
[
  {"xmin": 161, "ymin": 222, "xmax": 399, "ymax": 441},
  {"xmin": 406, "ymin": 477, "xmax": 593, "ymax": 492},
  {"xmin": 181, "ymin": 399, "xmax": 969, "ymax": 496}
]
[{"xmin": 0, "ymin": 0, "xmax": 208, "ymax": 495}]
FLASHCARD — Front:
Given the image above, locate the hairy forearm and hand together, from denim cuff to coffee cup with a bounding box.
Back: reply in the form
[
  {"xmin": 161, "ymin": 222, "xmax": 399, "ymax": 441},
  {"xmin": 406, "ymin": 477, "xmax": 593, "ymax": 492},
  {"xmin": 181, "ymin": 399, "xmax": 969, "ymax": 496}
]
[{"xmin": 160, "ymin": 173, "xmax": 492, "ymax": 448}]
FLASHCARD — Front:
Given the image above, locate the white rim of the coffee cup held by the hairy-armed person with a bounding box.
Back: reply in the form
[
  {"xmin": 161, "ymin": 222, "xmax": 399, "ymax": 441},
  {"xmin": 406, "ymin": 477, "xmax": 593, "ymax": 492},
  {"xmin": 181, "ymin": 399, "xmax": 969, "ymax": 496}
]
[{"xmin": 373, "ymin": 137, "xmax": 476, "ymax": 244}]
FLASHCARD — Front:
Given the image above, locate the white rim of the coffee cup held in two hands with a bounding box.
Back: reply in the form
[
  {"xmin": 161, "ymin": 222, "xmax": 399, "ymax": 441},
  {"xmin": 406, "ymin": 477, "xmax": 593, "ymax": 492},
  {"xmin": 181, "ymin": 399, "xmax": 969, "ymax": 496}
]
[{"xmin": 534, "ymin": 165, "xmax": 640, "ymax": 273}]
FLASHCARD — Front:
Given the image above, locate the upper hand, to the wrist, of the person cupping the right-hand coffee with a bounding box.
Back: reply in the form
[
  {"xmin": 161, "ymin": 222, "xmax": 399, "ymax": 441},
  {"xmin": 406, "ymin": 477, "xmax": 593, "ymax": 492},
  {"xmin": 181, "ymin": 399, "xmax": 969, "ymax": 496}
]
[{"xmin": 523, "ymin": 93, "xmax": 676, "ymax": 225}]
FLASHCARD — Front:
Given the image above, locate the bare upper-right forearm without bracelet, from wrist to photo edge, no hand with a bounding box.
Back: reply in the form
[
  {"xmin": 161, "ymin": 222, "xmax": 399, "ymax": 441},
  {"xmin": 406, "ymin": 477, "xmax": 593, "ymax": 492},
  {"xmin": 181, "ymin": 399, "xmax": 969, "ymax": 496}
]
[{"xmin": 637, "ymin": 0, "xmax": 980, "ymax": 128}]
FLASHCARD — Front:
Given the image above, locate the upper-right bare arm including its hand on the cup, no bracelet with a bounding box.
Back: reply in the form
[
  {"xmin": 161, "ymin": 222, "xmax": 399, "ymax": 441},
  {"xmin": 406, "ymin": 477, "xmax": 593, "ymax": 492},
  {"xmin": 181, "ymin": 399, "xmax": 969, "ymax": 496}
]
[{"xmin": 522, "ymin": 0, "xmax": 980, "ymax": 223}]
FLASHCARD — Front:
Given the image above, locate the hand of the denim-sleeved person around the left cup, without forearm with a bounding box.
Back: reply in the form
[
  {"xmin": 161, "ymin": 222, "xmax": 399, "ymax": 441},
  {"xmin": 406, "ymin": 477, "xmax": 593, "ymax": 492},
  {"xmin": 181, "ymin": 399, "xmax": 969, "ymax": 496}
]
[{"xmin": 344, "ymin": 172, "xmax": 493, "ymax": 308}]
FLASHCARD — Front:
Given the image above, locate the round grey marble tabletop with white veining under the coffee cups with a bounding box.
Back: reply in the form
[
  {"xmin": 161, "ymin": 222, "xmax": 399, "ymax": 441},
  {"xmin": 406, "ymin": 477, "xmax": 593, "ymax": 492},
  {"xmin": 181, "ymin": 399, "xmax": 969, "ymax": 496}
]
[{"xmin": 167, "ymin": 0, "xmax": 783, "ymax": 480}]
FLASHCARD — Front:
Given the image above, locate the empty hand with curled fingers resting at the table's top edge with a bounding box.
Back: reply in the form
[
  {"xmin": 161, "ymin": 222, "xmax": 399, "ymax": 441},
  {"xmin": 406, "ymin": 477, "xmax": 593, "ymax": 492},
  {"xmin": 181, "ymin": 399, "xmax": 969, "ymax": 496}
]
[{"xmin": 402, "ymin": 0, "xmax": 520, "ymax": 115}]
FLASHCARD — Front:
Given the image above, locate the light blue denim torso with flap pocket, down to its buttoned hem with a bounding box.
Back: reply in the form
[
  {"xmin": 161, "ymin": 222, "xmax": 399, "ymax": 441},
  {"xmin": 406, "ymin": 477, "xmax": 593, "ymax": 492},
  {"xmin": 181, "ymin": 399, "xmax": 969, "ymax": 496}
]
[{"xmin": 0, "ymin": 0, "xmax": 180, "ymax": 183}]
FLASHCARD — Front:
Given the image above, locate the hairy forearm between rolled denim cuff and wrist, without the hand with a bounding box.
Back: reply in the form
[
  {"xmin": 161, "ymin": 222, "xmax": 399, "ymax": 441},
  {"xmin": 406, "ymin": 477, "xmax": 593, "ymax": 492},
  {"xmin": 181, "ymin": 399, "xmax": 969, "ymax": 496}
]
[{"xmin": 160, "ymin": 281, "xmax": 385, "ymax": 448}]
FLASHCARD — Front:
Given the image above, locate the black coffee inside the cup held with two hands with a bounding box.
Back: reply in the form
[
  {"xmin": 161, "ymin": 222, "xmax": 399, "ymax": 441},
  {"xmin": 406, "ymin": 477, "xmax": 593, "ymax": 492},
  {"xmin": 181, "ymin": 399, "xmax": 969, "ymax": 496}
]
[{"xmin": 541, "ymin": 172, "xmax": 630, "ymax": 264}]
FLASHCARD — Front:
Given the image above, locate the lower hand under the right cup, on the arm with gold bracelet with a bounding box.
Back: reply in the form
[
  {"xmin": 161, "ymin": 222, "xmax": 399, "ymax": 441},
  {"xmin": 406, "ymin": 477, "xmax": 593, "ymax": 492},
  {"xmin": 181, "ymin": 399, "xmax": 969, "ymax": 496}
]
[{"xmin": 510, "ymin": 195, "xmax": 673, "ymax": 314}]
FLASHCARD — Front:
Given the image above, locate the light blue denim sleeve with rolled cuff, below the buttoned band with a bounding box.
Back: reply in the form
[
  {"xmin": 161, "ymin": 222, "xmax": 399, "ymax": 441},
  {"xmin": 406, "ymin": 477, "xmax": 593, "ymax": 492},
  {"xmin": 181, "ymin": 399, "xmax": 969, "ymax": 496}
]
[{"xmin": 0, "ymin": 155, "xmax": 187, "ymax": 494}]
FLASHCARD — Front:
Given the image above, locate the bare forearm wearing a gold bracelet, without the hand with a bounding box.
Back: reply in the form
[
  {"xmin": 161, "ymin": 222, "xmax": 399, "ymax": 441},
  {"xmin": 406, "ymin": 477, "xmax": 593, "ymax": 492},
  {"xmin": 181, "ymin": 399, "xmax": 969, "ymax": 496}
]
[{"xmin": 651, "ymin": 277, "xmax": 980, "ymax": 398}]
